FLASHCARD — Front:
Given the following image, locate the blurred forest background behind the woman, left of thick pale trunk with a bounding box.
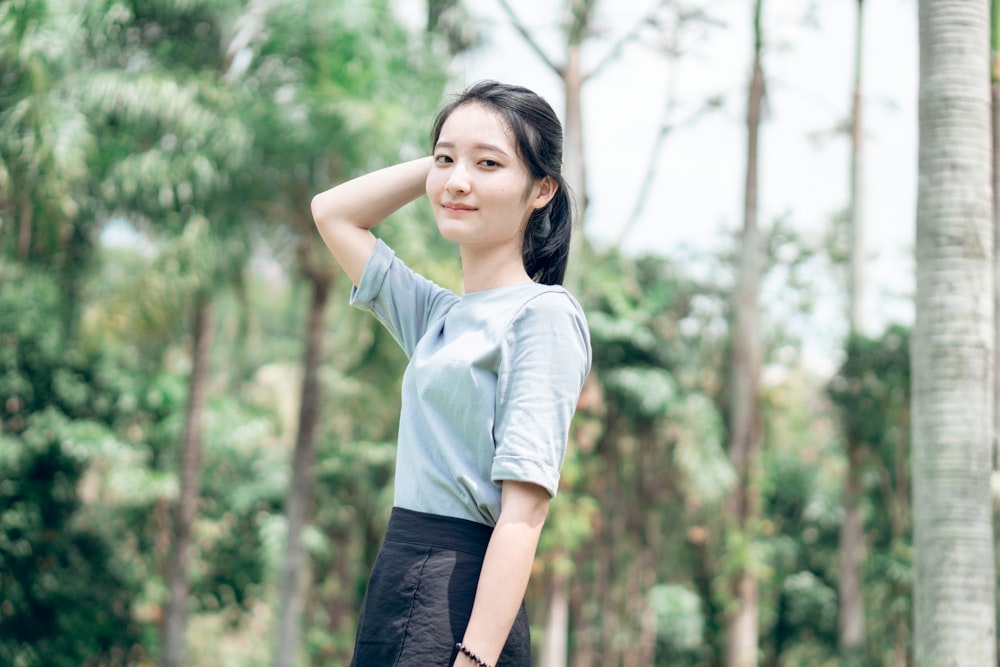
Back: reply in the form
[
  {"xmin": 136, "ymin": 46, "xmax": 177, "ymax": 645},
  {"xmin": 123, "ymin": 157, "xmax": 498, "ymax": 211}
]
[{"xmin": 0, "ymin": 0, "xmax": 996, "ymax": 667}]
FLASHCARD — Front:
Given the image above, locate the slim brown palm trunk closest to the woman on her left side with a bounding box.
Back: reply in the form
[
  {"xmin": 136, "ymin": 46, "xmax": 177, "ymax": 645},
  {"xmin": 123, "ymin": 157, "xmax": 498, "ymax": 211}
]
[{"xmin": 274, "ymin": 273, "xmax": 331, "ymax": 667}]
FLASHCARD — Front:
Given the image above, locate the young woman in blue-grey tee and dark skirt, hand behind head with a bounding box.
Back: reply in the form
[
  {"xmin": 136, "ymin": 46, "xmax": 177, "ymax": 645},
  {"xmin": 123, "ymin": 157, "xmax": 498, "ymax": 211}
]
[{"xmin": 312, "ymin": 82, "xmax": 590, "ymax": 667}]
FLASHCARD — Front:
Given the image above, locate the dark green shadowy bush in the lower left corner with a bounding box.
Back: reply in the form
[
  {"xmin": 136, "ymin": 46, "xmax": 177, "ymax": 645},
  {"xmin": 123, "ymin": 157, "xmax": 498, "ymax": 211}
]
[{"xmin": 0, "ymin": 420, "xmax": 141, "ymax": 667}]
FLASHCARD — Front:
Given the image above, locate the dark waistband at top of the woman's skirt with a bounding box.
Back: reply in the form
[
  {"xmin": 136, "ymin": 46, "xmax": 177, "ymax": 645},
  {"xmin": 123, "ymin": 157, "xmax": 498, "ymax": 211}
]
[{"xmin": 385, "ymin": 507, "xmax": 493, "ymax": 558}]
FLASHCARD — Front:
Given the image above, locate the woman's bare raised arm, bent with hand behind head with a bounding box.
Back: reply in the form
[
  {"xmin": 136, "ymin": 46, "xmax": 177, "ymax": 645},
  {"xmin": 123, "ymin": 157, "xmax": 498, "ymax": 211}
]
[{"xmin": 312, "ymin": 157, "xmax": 433, "ymax": 285}]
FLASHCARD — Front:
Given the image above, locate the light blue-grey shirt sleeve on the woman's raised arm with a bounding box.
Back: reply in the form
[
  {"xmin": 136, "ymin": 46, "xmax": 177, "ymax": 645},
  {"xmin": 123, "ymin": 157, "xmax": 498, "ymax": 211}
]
[{"xmin": 350, "ymin": 239, "xmax": 458, "ymax": 357}]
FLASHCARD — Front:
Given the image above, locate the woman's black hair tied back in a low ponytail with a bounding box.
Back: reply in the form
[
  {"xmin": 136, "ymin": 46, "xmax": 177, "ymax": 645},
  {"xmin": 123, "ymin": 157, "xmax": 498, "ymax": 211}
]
[{"xmin": 431, "ymin": 81, "xmax": 573, "ymax": 285}]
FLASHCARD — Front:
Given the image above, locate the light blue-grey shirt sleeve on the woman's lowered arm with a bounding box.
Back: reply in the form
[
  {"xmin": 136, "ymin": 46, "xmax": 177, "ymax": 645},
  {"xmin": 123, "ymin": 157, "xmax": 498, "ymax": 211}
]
[{"xmin": 491, "ymin": 290, "xmax": 591, "ymax": 497}]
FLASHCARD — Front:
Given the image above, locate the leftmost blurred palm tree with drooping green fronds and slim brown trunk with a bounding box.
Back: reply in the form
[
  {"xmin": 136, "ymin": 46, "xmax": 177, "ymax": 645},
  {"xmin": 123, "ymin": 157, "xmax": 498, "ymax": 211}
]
[{"xmin": 77, "ymin": 0, "xmax": 251, "ymax": 667}]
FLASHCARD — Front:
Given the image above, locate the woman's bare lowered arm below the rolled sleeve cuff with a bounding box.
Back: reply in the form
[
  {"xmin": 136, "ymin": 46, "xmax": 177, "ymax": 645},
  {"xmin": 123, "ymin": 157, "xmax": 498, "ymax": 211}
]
[{"xmin": 455, "ymin": 480, "xmax": 549, "ymax": 667}]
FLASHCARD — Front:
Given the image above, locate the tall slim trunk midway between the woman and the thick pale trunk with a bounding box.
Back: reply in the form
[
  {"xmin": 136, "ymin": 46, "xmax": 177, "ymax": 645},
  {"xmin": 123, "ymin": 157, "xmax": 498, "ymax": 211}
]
[{"xmin": 725, "ymin": 5, "xmax": 764, "ymax": 667}]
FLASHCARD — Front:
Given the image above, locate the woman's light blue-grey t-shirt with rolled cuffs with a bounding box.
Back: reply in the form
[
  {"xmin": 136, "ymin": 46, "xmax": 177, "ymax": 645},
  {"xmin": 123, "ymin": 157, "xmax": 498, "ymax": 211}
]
[{"xmin": 351, "ymin": 240, "xmax": 591, "ymax": 526}]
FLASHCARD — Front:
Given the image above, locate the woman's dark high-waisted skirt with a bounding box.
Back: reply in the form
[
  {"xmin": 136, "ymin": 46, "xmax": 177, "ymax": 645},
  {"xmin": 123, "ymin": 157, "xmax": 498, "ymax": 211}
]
[{"xmin": 351, "ymin": 507, "xmax": 531, "ymax": 667}]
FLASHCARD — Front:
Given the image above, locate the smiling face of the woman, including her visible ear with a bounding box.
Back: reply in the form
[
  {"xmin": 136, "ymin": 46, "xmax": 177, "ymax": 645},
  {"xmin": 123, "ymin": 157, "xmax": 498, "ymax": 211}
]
[{"xmin": 426, "ymin": 102, "xmax": 551, "ymax": 256}]
